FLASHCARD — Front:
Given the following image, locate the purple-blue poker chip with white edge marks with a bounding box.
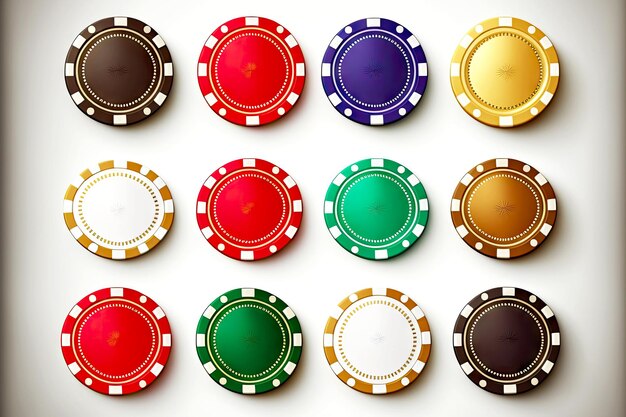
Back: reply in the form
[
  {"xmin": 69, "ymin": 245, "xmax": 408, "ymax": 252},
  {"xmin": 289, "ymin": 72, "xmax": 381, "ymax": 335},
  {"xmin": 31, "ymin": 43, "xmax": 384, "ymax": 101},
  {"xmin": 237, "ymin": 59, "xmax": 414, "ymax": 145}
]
[{"xmin": 322, "ymin": 18, "xmax": 428, "ymax": 126}]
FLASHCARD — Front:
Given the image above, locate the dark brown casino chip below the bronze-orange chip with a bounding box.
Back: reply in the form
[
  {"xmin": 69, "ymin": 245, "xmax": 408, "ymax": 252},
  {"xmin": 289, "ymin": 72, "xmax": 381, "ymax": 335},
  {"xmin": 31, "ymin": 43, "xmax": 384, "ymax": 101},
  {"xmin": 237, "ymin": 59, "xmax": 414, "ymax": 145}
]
[{"xmin": 453, "ymin": 288, "xmax": 561, "ymax": 394}]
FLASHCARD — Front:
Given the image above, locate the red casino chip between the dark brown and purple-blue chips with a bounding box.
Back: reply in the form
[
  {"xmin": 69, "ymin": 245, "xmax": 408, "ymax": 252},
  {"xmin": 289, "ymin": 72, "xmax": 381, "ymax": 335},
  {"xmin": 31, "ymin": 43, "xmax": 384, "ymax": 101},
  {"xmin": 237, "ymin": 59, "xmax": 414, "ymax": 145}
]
[{"xmin": 198, "ymin": 17, "xmax": 305, "ymax": 126}]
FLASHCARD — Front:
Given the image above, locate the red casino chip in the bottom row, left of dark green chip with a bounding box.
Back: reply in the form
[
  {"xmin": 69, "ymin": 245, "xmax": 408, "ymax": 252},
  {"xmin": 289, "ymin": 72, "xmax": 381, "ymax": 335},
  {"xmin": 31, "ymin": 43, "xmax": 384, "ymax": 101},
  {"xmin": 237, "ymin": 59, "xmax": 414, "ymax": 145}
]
[{"xmin": 61, "ymin": 288, "xmax": 172, "ymax": 395}]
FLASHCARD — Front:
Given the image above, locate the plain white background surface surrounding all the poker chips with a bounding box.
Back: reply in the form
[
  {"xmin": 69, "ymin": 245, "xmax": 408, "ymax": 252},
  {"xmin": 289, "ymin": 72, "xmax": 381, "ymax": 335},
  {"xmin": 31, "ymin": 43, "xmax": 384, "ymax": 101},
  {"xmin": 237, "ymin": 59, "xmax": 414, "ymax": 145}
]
[{"xmin": 0, "ymin": 0, "xmax": 626, "ymax": 417}]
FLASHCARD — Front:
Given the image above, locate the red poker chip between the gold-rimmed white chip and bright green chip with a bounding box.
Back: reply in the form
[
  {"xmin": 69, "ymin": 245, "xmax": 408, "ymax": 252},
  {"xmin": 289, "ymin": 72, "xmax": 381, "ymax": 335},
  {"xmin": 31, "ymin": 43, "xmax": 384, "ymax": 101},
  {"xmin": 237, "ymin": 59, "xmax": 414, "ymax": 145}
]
[{"xmin": 196, "ymin": 159, "xmax": 302, "ymax": 261}]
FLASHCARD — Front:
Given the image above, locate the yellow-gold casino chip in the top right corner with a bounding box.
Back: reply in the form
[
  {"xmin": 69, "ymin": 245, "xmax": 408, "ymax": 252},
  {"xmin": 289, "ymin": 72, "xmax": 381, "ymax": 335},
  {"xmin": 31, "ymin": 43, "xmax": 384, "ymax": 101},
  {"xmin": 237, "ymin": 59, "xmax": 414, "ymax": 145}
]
[{"xmin": 450, "ymin": 17, "xmax": 559, "ymax": 127}]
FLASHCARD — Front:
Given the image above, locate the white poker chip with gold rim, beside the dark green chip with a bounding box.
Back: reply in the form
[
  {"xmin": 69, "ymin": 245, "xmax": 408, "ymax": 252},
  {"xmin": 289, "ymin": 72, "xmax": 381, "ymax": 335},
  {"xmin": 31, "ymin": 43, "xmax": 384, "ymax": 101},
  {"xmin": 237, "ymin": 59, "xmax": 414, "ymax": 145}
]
[{"xmin": 324, "ymin": 288, "xmax": 431, "ymax": 394}]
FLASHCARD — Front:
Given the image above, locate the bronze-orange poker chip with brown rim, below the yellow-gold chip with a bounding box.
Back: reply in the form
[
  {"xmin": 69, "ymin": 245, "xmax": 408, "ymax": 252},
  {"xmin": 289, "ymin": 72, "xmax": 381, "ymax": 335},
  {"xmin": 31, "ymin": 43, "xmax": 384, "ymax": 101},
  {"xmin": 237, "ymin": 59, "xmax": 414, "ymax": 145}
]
[{"xmin": 450, "ymin": 159, "xmax": 556, "ymax": 259}]
